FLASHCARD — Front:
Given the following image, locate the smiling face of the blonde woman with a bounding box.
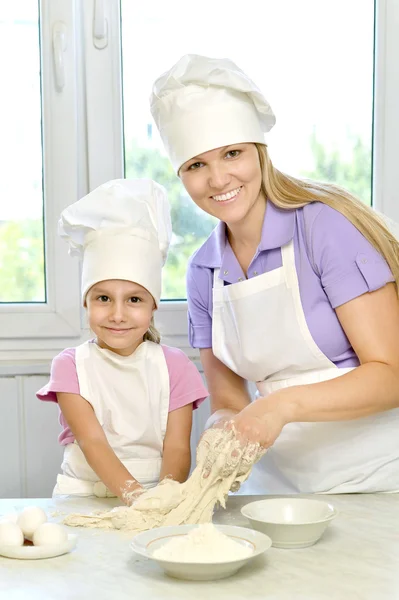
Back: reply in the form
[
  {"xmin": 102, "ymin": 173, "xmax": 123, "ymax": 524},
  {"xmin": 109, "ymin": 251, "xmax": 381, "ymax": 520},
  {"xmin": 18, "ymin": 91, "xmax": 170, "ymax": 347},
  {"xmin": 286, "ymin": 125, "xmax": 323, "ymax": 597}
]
[{"xmin": 179, "ymin": 144, "xmax": 264, "ymax": 225}]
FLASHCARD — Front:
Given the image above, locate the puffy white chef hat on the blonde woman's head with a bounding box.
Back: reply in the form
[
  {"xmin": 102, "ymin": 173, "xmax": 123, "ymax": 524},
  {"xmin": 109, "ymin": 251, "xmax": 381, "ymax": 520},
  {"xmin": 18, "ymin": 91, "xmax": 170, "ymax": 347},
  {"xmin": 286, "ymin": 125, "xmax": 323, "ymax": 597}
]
[{"xmin": 150, "ymin": 54, "xmax": 276, "ymax": 172}]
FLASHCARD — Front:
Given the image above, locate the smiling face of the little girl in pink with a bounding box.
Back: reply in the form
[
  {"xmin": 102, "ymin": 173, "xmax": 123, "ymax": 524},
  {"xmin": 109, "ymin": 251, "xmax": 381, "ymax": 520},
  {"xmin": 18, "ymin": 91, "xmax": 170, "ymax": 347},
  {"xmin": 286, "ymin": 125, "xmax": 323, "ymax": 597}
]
[{"xmin": 86, "ymin": 279, "xmax": 155, "ymax": 356}]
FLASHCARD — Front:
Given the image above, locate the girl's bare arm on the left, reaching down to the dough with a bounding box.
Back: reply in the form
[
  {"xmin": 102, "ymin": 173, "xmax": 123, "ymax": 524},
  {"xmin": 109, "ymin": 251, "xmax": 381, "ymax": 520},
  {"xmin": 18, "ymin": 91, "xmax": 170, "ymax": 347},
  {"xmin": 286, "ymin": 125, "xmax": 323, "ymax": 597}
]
[{"xmin": 57, "ymin": 392, "xmax": 141, "ymax": 502}]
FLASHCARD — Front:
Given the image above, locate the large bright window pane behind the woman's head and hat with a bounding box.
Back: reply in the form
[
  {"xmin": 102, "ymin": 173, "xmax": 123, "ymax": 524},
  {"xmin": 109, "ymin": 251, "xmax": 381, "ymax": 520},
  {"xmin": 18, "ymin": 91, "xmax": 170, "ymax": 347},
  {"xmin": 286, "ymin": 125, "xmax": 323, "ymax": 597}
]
[{"xmin": 121, "ymin": 0, "xmax": 374, "ymax": 299}]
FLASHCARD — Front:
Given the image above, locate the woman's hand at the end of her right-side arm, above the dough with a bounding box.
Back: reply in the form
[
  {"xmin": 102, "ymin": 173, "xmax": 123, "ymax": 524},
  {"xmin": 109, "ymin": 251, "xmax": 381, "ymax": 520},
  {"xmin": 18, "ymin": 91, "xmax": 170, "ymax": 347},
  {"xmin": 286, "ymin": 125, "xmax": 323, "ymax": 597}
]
[{"xmin": 231, "ymin": 394, "xmax": 290, "ymax": 448}]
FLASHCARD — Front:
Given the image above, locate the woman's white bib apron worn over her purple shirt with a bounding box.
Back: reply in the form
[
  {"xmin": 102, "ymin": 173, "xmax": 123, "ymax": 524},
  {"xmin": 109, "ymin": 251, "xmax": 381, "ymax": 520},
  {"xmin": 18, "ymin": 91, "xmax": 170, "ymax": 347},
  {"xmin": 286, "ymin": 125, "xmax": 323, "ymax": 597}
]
[{"xmin": 212, "ymin": 241, "xmax": 399, "ymax": 494}]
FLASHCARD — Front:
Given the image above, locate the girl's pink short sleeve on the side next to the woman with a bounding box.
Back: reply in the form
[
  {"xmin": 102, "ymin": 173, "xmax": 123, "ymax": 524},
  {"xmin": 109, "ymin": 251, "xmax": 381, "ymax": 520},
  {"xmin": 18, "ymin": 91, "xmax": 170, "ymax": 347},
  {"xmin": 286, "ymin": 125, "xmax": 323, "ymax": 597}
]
[{"xmin": 162, "ymin": 346, "xmax": 209, "ymax": 412}]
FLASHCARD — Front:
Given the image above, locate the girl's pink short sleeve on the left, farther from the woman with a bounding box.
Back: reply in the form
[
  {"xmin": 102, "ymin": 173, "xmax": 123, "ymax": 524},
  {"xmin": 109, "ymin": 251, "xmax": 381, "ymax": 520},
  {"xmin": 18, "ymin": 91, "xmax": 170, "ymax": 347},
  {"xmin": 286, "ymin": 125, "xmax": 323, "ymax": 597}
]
[{"xmin": 36, "ymin": 348, "xmax": 80, "ymax": 402}]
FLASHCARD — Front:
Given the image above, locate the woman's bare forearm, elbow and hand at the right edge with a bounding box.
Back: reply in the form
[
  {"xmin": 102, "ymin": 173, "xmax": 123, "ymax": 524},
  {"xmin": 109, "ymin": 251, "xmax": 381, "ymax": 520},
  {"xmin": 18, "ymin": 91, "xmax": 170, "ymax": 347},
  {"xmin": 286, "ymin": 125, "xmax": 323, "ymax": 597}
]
[{"xmin": 235, "ymin": 283, "xmax": 399, "ymax": 447}]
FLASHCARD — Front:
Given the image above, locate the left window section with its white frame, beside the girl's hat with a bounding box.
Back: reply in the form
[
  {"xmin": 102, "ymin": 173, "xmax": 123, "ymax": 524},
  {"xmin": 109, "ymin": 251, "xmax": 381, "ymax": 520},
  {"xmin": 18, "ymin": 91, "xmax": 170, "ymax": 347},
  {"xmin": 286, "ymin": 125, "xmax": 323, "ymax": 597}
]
[{"xmin": 0, "ymin": 0, "xmax": 81, "ymax": 360}]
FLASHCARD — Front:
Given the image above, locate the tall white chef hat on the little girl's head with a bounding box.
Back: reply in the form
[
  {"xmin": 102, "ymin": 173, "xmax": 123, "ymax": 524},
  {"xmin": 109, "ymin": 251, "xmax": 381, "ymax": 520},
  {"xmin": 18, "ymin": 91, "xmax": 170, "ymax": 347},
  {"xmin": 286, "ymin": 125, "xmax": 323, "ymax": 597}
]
[{"xmin": 58, "ymin": 179, "xmax": 172, "ymax": 306}]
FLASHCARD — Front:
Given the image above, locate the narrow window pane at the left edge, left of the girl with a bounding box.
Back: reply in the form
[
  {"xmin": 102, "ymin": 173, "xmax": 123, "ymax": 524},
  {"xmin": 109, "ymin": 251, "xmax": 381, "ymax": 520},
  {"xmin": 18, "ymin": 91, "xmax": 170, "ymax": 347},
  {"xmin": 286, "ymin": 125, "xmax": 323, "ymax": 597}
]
[{"xmin": 0, "ymin": 0, "xmax": 46, "ymax": 303}]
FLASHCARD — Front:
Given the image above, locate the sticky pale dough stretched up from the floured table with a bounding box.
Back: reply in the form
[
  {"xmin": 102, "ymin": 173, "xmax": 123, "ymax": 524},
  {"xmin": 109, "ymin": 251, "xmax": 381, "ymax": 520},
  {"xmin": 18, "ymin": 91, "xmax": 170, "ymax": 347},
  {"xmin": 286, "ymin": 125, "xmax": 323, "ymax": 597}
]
[{"xmin": 63, "ymin": 428, "xmax": 265, "ymax": 533}]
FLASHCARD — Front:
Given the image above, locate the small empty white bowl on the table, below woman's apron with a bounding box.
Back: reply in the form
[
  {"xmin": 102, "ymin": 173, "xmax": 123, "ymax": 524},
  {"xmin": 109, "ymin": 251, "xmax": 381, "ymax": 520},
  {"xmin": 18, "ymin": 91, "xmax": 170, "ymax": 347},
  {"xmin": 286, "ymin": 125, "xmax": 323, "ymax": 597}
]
[{"xmin": 241, "ymin": 497, "xmax": 338, "ymax": 548}]
